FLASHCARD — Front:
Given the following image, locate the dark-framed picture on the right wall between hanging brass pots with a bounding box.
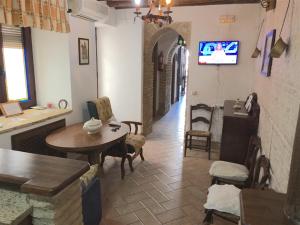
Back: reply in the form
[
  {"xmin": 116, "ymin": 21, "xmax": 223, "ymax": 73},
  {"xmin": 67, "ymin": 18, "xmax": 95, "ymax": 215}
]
[{"xmin": 261, "ymin": 29, "xmax": 276, "ymax": 77}]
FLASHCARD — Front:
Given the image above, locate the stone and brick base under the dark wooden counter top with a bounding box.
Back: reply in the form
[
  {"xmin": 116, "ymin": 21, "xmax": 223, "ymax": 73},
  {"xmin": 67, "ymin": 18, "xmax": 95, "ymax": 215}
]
[{"xmin": 0, "ymin": 179, "xmax": 83, "ymax": 225}]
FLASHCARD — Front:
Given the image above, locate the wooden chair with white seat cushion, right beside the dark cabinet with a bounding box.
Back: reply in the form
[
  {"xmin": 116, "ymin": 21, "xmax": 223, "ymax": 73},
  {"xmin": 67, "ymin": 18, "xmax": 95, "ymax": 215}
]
[{"xmin": 209, "ymin": 135, "xmax": 261, "ymax": 188}]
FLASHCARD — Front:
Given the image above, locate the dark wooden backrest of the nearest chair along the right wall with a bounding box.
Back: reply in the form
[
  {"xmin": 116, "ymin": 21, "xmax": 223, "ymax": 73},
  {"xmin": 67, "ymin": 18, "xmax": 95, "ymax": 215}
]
[{"xmin": 251, "ymin": 155, "xmax": 271, "ymax": 189}]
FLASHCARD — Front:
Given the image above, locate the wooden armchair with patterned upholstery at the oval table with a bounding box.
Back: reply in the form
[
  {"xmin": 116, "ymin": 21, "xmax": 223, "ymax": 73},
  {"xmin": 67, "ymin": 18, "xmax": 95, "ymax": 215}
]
[{"xmin": 87, "ymin": 97, "xmax": 145, "ymax": 179}]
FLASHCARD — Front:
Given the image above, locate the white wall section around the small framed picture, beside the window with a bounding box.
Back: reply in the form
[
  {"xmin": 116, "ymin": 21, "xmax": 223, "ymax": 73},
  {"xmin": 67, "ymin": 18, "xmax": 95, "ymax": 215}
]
[{"xmin": 32, "ymin": 16, "xmax": 97, "ymax": 124}]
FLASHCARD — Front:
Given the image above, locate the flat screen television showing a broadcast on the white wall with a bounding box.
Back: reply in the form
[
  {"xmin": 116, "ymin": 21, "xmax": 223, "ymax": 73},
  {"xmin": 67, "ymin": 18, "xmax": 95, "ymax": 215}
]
[{"xmin": 198, "ymin": 41, "xmax": 239, "ymax": 65}]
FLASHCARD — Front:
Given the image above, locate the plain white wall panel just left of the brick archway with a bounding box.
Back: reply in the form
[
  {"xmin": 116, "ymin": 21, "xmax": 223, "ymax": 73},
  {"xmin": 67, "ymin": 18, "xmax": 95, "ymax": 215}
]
[{"xmin": 97, "ymin": 14, "xmax": 143, "ymax": 121}]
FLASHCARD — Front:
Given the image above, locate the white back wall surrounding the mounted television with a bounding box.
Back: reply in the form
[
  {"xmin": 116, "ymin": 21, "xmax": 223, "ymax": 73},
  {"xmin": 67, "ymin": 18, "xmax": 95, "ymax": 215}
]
[{"xmin": 173, "ymin": 4, "xmax": 260, "ymax": 137}]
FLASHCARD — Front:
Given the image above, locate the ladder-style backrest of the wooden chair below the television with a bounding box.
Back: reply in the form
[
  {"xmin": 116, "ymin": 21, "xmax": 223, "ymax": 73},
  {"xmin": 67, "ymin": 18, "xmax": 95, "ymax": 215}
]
[{"xmin": 190, "ymin": 103, "xmax": 214, "ymax": 131}]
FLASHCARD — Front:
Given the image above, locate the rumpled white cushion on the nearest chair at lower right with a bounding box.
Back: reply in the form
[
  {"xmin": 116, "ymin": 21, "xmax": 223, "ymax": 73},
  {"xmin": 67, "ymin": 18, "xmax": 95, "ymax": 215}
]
[{"xmin": 204, "ymin": 184, "xmax": 241, "ymax": 216}]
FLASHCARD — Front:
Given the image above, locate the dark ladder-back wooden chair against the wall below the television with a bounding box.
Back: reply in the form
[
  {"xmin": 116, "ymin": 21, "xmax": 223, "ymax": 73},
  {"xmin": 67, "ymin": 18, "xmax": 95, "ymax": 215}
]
[{"xmin": 184, "ymin": 103, "xmax": 214, "ymax": 159}]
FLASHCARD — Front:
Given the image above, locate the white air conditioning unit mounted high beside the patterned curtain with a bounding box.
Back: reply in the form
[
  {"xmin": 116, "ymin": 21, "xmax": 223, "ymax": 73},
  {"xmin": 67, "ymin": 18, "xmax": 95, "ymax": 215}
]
[{"xmin": 68, "ymin": 0, "xmax": 109, "ymax": 22}]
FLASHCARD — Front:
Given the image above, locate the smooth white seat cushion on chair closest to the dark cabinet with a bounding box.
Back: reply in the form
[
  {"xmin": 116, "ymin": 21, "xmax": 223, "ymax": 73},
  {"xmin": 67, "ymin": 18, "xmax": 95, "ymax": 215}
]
[{"xmin": 209, "ymin": 161, "xmax": 249, "ymax": 181}]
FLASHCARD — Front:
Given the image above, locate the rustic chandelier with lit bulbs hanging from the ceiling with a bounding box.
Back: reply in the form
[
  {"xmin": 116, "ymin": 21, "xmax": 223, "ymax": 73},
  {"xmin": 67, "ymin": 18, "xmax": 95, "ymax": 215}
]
[{"xmin": 134, "ymin": 0, "xmax": 173, "ymax": 26}]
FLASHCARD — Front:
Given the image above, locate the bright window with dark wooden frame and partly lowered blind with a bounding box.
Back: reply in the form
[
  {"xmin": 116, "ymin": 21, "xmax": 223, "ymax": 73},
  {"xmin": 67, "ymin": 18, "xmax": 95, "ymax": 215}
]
[{"xmin": 0, "ymin": 25, "xmax": 36, "ymax": 109}]
